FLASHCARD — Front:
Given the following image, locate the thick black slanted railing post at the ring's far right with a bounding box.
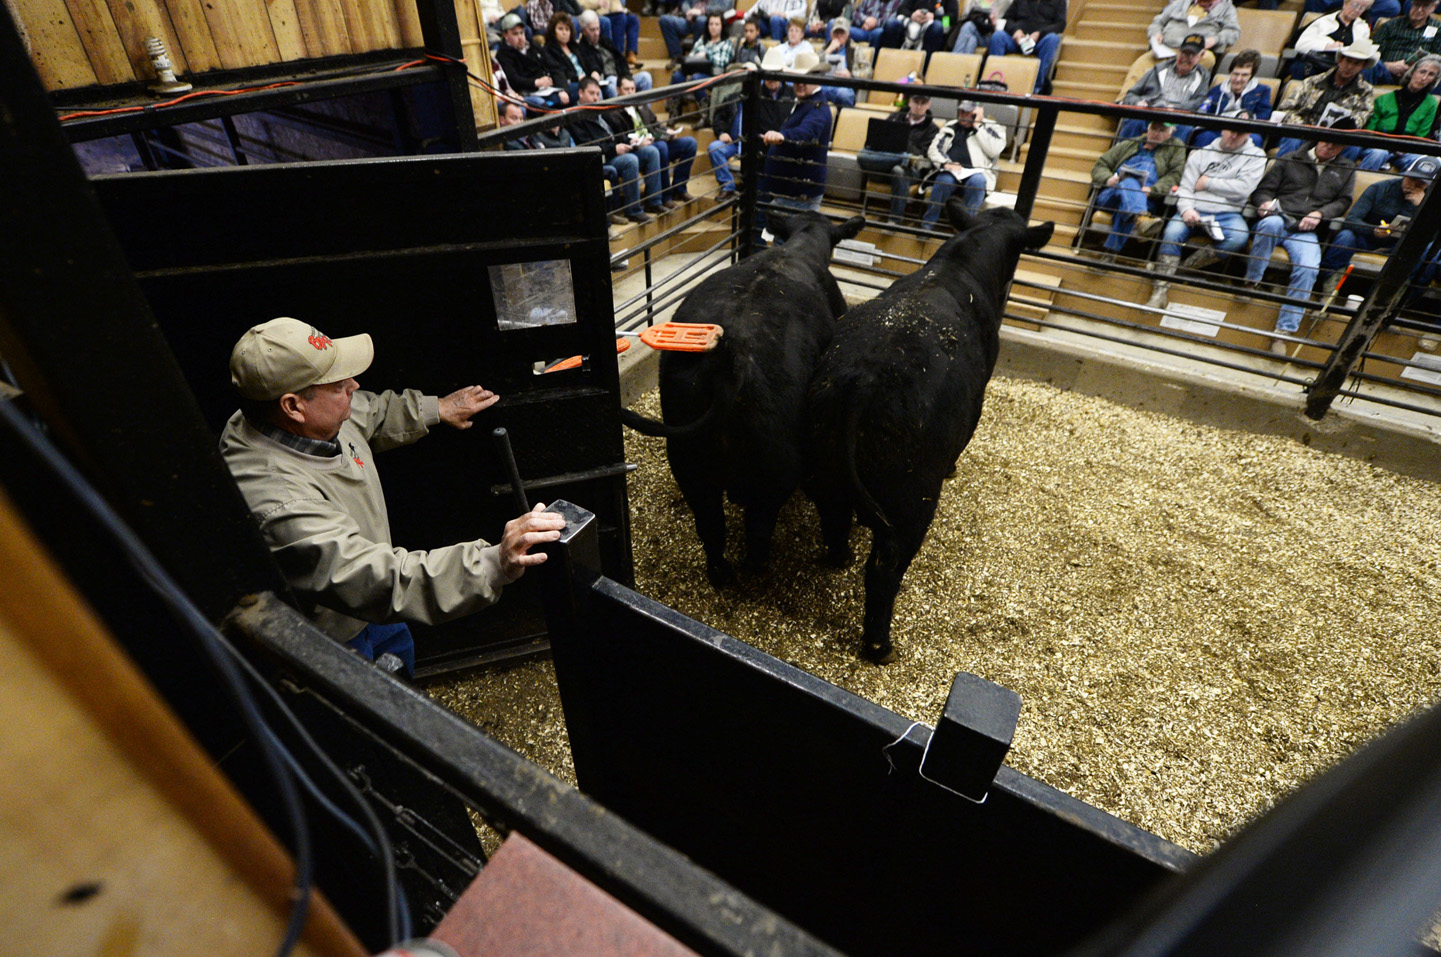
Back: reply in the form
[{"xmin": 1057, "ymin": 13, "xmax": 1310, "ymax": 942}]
[{"xmin": 1306, "ymin": 179, "xmax": 1441, "ymax": 419}]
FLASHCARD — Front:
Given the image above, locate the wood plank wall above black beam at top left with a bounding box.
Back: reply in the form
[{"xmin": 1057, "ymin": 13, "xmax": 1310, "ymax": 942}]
[{"xmin": 6, "ymin": 0, "xmax": 426, "ymax": 91}]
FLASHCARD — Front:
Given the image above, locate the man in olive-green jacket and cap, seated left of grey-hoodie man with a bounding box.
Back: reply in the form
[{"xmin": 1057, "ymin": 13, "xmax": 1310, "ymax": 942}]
[{"xmin": 1091, "ymin": 120, "xmax": 1186, "ymax": 262}]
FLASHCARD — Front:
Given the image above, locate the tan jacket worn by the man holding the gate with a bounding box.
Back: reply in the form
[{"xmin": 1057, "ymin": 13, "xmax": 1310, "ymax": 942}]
[{"xmin": 220, "ymin": 391, "xmax": 506, "ymax": 641}]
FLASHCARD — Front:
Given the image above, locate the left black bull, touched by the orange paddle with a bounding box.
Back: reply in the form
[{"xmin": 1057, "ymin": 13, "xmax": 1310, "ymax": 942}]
[{"xmin": 623, "ymin": 213, "xmax": 865, "ymax": 588}]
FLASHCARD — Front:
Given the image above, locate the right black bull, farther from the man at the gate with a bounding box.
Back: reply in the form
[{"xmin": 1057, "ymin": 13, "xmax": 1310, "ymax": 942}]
[{"xmin": 804, "ymin": 199, "xmax": 1053, "ymax": 662}]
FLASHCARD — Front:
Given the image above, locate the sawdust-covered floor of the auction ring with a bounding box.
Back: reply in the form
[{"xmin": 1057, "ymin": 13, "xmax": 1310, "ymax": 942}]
[{"xmin": 429, "ymin": 379, "xmax": 1441, "ymax": 852}]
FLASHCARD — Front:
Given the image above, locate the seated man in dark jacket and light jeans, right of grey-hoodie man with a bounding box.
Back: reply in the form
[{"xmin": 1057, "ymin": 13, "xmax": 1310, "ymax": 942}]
[{"xmin": 1246, "ymin": 118, "xmax": 1356, "ymax": 356}]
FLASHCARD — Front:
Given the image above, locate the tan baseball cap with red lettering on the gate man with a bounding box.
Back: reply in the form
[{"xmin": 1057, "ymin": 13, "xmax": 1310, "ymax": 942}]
[{"xmin": 231, "ymin": 316, "xmax": 375, "ymax": 399}]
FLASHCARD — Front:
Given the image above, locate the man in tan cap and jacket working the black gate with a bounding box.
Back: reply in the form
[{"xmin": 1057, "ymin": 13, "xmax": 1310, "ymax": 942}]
[{"xmin": 220, "ymin": 319, "xmax": 565, "ymax": 673}]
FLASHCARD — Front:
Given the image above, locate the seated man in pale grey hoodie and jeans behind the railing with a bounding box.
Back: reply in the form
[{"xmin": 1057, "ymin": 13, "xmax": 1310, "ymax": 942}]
[{"xmin": 1146, "ymin": 112, "xmax": 1265, "ymax": 308}]
